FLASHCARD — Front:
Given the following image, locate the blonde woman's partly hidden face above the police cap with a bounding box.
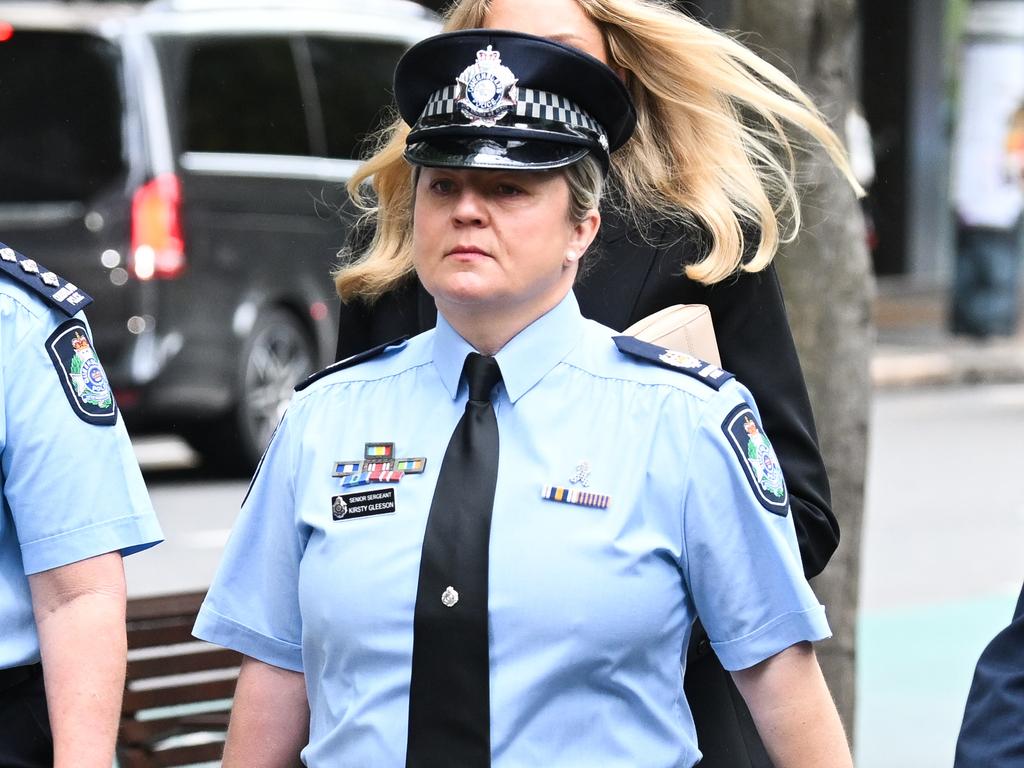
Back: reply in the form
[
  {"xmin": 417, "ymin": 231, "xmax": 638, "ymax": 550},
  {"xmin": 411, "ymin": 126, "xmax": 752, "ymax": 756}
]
[{"xmin": 483, "ymin": 0, "xmax": 608, "ymax": 63}]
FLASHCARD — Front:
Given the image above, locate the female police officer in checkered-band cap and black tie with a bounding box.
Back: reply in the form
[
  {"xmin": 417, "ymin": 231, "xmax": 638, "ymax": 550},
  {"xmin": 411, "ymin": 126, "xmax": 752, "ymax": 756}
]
[{"xmin": 196, "ymin": 31, "xmax": 850, "ymax": 768}]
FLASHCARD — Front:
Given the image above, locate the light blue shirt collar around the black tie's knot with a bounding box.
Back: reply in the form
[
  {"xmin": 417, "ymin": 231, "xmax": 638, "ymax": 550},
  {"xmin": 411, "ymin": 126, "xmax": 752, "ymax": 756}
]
[{"xmin": 434, "ymin": 291, "xmax": 584, "ymax": 402}]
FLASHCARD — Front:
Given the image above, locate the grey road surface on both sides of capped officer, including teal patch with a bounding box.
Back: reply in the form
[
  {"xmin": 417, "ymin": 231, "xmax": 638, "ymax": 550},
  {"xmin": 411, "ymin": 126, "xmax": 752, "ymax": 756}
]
[{"xmin": 126, "ymin": 386, "xmax": 1024, "ymax": 768}]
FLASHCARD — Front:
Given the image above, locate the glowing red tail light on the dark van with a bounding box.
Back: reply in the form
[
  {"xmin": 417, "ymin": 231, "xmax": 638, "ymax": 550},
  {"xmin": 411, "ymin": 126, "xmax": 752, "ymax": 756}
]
[{"xmin": 128, "ymin": 173, "xmax": 185, "ymax": 280}]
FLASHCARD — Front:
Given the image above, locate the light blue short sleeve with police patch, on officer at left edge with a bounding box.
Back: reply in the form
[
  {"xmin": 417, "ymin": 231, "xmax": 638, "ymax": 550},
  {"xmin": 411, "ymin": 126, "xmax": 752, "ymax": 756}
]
[{"xmin": 0, "ymin": 296, "xmax": 162, "ymax": 574}]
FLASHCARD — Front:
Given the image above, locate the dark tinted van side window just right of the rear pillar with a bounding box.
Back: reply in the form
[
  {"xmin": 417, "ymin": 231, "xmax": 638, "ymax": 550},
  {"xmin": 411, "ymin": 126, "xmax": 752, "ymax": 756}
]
[{"xmin": 184, "ymin": 37, "xmax": 309, "ymax": 155}]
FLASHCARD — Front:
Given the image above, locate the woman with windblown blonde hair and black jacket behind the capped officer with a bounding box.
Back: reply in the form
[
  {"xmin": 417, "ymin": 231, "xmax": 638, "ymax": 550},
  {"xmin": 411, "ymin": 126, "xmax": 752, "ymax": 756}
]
[{"xmin": 337, "ymin": 0, "xmax": 856, "ymax": 768}]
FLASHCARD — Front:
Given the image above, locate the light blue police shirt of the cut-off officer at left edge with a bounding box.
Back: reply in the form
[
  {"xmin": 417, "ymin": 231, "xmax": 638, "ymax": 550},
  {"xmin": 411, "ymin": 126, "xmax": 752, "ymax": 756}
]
[{"xmin": 0, "ymin": 272, "xmax": 162, "ymax": 669}]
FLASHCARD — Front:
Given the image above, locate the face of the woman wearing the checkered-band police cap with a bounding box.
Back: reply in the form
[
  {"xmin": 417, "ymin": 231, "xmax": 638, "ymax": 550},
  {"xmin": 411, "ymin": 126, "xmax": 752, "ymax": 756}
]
[{"xmin": 413, "ymin": 168, "xmax": 600, "ymax": 327}]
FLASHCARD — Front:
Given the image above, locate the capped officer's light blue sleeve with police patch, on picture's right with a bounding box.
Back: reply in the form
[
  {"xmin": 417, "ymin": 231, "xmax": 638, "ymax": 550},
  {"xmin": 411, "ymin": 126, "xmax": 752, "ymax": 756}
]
[{"xmin": 682, "ymin": 384, "xmax": 830, "ymax": 670}]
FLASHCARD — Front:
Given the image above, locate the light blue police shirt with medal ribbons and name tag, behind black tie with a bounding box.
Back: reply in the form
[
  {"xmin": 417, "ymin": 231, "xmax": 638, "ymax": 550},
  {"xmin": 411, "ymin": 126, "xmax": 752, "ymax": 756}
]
[{"xmin": 195, "ymin": 293, "xmax": 828, "ymax": 768}]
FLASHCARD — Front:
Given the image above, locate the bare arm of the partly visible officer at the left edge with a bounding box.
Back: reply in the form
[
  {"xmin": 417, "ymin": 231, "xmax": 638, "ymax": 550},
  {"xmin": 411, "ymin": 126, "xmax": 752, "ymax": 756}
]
[{"xmin": 30, "ymin": 553, "xmax": 127, "ymax": 768}]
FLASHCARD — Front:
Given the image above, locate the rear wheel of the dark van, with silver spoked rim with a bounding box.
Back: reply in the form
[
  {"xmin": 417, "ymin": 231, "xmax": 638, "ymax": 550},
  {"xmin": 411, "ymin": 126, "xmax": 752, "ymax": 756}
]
[{"xmin": 188, "ymin": 309, "xmax": 314, "ymax": 474}]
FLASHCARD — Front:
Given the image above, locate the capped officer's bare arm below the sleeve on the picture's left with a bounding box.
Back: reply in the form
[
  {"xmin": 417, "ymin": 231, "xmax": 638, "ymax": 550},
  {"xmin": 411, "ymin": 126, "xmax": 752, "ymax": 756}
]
[{"xmin": 223, "ymin": 656, "xmax": 309, "ymax": 768}]
